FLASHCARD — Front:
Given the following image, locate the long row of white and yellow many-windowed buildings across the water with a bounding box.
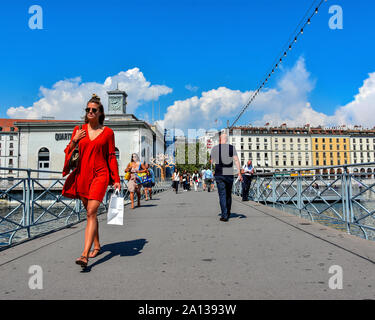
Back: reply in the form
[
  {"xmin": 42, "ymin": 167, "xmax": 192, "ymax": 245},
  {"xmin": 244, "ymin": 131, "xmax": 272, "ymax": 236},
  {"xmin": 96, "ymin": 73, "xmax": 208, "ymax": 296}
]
[{"xmin": 200, "ymin": 124, "xmax": 375, "ymax": 173}]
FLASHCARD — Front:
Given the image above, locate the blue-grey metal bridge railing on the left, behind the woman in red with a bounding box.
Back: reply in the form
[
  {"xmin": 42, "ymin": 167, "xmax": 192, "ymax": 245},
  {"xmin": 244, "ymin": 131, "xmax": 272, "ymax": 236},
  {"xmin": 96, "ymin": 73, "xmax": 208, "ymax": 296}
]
[{"xmin": 0, "ymin": 167, "xmax": 171, "ymax": 250}]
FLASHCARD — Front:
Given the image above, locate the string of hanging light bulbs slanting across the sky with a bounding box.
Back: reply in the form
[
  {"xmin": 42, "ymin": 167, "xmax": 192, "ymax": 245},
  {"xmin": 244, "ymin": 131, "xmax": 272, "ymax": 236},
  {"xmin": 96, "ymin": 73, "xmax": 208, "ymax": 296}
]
[{"xmin": 229, "ymin": 0, "xmax": 327, "ymax": 129}]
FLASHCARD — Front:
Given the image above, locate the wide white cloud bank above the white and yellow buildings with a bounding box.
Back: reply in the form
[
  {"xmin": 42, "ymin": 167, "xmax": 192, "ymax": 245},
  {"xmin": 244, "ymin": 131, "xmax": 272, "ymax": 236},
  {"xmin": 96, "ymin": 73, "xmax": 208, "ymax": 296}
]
[{"xmin": 163, "ymin": 58, "xmax": 375, "ymax": 129}]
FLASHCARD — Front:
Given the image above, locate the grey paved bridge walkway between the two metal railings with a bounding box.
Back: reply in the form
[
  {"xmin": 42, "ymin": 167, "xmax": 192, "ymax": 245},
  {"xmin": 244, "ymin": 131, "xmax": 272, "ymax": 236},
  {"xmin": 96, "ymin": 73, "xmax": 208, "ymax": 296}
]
[{"xmin": 0, "ymin": 191, "xmax": 375, "ymax": 300}]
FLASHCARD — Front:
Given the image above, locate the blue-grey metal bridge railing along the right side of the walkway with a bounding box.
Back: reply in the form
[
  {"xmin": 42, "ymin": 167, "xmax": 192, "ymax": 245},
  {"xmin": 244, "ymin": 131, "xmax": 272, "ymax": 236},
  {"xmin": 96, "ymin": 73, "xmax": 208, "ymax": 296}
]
[{"xmin": 233, "ymin": 163, "xmax": 375, "ymax": 240}]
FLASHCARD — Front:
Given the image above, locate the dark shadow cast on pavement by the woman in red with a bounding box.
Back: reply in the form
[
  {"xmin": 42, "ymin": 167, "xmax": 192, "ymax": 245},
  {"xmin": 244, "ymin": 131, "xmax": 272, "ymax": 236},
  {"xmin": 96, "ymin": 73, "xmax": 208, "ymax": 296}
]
[{"xmin": 82, "ymin": 239, "xmax": 148, "ymax": 272}]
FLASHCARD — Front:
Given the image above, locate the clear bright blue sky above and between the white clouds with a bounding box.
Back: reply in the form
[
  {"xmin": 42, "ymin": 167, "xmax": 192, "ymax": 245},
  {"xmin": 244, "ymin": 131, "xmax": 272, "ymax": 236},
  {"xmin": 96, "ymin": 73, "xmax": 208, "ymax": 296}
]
[{"xmin": 0, "ymin": 0, "xmax": 375, "ymax": 126}]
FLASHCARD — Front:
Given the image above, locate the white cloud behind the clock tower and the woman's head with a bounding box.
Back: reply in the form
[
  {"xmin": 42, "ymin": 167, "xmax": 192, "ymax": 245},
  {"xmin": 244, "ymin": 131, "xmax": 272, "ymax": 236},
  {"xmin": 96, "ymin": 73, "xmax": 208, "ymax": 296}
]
[{"xmin": 7, "ymin": 68, "xmax": 172, "ymax": 120}]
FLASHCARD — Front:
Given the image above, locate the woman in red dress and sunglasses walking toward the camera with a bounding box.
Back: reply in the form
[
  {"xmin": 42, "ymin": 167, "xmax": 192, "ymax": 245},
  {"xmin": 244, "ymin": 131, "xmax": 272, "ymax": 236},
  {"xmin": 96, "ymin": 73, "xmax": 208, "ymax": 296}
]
[{"xmin": 63, "ymin": 94, "xmax": 121, "ymax": 267}]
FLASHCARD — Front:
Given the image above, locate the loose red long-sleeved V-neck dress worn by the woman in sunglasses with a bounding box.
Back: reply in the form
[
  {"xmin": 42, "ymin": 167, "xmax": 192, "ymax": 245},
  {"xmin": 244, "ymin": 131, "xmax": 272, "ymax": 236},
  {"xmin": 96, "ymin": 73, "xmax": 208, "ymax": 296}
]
[{"xmin": 62, "ymin": 124, "xmax": 120, "ymax": 202}]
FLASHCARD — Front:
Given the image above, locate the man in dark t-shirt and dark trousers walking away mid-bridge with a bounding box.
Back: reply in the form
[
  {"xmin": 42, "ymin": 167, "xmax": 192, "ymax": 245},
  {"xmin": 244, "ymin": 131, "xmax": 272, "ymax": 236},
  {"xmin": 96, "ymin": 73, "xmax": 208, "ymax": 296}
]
[{"xmin": 211, "ymin": 131, "xmax": 243, "ymax": 221}]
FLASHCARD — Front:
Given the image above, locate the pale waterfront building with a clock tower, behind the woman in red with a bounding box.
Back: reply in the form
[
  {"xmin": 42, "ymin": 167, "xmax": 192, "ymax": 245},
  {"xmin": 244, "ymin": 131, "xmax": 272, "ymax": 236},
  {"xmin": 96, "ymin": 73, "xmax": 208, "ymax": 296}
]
[{"xmin": 0, "ymin": 89, "xmax": 165, "ymax": 178}]
